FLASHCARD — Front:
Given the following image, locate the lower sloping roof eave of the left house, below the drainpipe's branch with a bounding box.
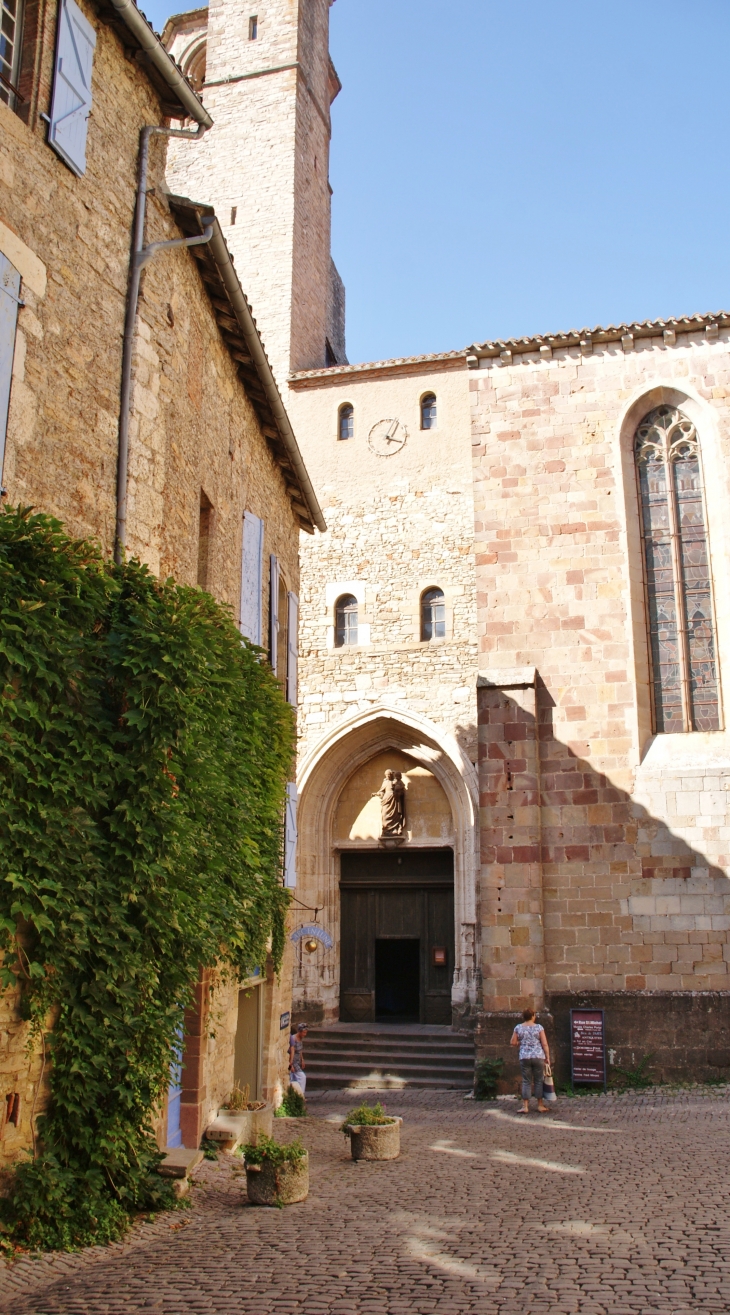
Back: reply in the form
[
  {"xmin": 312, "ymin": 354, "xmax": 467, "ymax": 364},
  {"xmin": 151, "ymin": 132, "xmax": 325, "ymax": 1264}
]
[{"xmin": 167, "ymin": 196, "xmax": 326, "ymax": 534}]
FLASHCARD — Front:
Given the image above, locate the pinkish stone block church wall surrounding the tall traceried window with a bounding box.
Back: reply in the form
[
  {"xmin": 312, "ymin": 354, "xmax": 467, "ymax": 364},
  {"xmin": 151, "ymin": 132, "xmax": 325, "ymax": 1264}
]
[{"xmin": 470, "ymin": 329, "xmax": 730, "ymax": 1010}]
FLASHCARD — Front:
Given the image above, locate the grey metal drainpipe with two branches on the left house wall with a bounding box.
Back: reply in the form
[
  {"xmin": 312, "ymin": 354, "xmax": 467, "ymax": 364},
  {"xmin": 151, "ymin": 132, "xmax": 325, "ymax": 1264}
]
[{"xmin": 114, "ymin": 124, "xmax": 213, "ymax": 565}]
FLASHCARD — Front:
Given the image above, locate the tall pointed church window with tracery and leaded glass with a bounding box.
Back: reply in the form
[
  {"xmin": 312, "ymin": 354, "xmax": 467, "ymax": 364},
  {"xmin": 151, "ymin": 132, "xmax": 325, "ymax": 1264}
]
[{"xmin": 634, "ymin": 406, "xmax": 719, "ymax": 734}]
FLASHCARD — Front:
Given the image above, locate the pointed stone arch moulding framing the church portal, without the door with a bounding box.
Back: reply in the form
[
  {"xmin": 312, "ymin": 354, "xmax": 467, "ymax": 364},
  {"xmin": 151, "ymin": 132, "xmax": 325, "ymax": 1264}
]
[{"xmin": 295, "ymin": 701, "xmax": 479, "ymax": 1018}]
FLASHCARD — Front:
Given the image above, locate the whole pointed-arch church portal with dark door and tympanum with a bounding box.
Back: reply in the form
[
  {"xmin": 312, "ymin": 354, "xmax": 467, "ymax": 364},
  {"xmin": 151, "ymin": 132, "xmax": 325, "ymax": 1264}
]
[{"xmin": 293, "ymin": 706, "xmax": 477, "ymax": 1023}]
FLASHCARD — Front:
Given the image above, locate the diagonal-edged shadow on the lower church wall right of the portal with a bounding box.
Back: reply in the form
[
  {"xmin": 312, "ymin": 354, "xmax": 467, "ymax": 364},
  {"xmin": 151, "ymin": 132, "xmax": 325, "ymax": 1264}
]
[{"xmin": 475, "ymin": 681, "xmax": 730, "ymax": 1090}]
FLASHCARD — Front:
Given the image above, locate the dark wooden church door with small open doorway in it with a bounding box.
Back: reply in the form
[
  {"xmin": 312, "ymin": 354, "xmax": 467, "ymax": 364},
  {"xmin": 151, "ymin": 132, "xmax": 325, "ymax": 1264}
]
[{"xmin": 339, "ymin": 849, "xmax": 454, "ymax": 1023}]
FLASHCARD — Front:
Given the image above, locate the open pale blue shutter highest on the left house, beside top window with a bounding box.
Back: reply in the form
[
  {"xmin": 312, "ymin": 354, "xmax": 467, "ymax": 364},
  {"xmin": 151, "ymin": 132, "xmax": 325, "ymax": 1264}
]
[{"xmin": 49, "ymin": 0, "xmax": 96, "ymax": 176}]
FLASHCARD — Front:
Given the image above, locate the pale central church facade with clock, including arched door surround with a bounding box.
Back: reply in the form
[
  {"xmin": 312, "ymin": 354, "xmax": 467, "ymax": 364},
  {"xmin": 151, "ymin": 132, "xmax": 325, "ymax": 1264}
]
[{"xmin": 289, "ymin": 360, "xmax": 484, "ymax": 1020}]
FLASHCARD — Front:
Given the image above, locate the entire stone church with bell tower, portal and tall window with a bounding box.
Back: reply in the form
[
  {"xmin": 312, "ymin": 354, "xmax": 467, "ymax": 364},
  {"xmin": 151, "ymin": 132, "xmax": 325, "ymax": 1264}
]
[{"xmin": 163, "ymin": 0, "xmax": 730, "ymax": 1077}]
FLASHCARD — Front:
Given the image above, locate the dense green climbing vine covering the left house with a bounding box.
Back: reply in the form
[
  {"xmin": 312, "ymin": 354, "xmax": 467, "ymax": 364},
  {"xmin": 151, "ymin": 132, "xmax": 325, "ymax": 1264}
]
[{"xmin": 0, "ymin": 508, "xmax": 293, "ymax": 1247}]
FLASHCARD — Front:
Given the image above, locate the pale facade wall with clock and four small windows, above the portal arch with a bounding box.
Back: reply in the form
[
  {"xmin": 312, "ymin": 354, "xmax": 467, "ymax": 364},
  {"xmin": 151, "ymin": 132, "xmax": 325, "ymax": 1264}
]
[{"xmin": 289, "ymin": 364, "xmax": 476, "ymax": 761}]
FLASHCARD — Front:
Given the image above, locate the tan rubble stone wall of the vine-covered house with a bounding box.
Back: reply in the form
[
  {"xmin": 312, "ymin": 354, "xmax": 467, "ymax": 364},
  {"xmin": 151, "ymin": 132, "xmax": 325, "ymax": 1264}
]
[{"xmin": 0, "ymin": 0, "xmax": 299, "ymax": 1157}]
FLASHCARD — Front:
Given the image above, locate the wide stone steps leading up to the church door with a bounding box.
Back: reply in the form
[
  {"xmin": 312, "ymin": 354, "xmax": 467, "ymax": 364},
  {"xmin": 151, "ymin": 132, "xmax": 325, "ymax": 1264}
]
[{"xmin": 304, "ymin": 1023, "xmax": 474, "ymax": 1093}]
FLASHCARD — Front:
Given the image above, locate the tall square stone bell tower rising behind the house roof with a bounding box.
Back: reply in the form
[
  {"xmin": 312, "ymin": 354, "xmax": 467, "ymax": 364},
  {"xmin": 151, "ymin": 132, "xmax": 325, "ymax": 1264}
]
[{"xmin": 163, "ymin": 0, "xmax": 346, "ymax": 393}]
